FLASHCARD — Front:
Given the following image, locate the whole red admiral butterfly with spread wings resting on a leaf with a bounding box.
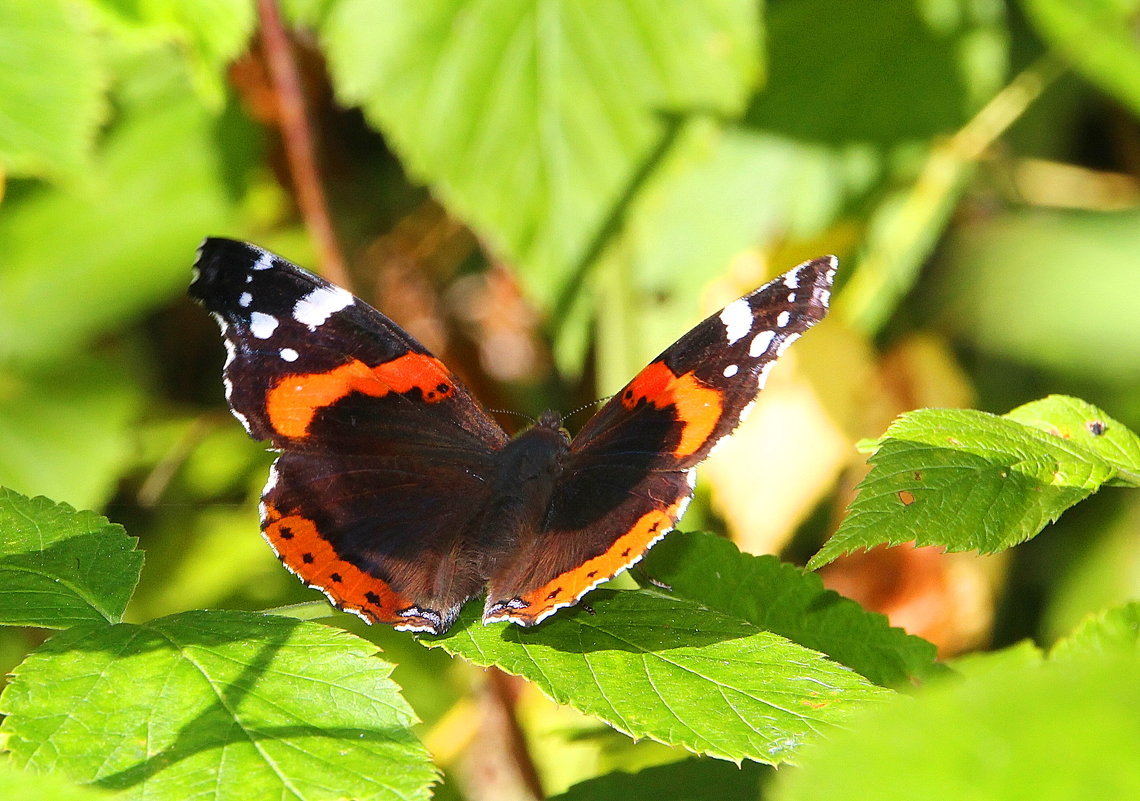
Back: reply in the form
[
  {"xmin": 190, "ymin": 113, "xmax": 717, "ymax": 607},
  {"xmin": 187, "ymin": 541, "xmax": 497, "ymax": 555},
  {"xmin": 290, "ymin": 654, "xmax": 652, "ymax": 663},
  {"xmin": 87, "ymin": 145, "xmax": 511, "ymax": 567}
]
[{"xmin": 190, "ymin": 239, "xmax": 837, "ymax": 634}]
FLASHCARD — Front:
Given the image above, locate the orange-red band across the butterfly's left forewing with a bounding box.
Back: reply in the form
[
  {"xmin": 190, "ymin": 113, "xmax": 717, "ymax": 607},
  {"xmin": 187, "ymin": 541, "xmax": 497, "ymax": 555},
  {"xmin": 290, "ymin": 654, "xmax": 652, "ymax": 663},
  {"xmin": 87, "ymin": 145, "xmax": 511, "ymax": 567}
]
[{"xmin": 266, "ymin": 353, "xmax": 455, "ymax": 438}]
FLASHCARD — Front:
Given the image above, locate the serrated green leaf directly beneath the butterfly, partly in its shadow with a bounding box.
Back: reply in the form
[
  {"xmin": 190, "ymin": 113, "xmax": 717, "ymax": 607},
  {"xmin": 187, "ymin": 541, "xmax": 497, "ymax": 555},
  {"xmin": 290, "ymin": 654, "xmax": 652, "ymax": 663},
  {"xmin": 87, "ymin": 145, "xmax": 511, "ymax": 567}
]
[{"xmin": 422, "ymin": 590, "xmax": 887, "ymax": 765}]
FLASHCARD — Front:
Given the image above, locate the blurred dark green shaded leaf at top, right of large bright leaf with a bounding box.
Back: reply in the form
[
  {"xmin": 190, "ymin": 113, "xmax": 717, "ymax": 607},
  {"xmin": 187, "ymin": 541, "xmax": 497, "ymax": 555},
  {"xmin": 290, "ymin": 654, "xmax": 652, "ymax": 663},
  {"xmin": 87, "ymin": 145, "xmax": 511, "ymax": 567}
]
[{"xmin": 748, "ymin": 0, "xmax": 1008, "ymax": 145}]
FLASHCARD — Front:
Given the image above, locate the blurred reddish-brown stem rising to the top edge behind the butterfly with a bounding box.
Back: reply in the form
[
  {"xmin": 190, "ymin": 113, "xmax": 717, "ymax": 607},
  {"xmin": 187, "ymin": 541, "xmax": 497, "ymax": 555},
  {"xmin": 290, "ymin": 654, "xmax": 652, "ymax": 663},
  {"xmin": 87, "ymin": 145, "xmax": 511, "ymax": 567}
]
[{"xmin": 258, "ymin": 0, "xmax": 351, "ymax": 288}]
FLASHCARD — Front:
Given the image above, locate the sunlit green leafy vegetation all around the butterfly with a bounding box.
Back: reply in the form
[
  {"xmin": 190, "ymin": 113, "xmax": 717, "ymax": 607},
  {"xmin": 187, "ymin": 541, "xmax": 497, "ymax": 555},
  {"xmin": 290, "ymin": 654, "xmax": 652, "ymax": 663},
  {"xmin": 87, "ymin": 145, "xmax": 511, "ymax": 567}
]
[{"xmin": 0, "ymin": 0, "xmax": 1140, "ymax": 799}]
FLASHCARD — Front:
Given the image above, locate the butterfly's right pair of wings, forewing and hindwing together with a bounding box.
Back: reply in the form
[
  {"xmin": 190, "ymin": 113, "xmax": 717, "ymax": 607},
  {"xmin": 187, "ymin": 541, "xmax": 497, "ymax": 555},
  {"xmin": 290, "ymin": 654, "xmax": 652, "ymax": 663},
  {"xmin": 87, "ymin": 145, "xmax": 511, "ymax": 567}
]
[{"xmin": 483, "ymin": 256, "xmax": 838, "ymax": 626}]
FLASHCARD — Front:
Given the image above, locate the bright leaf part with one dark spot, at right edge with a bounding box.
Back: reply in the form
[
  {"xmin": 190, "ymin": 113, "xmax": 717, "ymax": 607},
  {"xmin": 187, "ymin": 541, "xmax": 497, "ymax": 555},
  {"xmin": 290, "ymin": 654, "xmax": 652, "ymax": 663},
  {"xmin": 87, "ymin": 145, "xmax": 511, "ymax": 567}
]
[{"xmin": 1005, "ymin": 395, "xmax": 1140, "ymax": 487}]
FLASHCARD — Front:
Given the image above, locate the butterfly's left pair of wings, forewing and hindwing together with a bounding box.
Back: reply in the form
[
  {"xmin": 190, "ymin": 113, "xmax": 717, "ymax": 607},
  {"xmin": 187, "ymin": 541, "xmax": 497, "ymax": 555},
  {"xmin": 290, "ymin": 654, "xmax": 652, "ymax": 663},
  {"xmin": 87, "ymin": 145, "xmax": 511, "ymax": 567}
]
[{"xmin": 189, "ymin": 238, "xmax": 507, "ymax": 632}]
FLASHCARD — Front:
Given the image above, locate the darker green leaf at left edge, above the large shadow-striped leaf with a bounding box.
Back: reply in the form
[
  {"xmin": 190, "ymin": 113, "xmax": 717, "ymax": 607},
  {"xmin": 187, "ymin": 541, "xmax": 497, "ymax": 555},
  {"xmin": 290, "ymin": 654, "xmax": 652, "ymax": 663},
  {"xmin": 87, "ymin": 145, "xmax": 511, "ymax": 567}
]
[{"xmin": 0, "ymin": 488, "xmax": 143, "ymax": 629}]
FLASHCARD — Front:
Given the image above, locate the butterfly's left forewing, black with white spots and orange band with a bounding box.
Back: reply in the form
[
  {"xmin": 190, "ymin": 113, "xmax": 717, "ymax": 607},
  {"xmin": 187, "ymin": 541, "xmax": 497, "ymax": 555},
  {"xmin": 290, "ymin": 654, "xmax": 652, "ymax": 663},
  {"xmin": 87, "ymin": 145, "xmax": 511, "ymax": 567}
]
[{"xmin": 189, "ymin": 238, "xmax": 507, "ymax": 450}]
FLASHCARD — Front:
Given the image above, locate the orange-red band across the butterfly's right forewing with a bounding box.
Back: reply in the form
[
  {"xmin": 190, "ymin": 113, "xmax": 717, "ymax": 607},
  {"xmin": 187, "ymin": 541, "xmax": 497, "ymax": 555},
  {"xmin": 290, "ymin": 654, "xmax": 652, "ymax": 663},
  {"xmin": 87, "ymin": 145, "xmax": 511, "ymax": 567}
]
[{"xmin": 621, "ymin": 361, "xmax": 724, "ymax": 459}]
